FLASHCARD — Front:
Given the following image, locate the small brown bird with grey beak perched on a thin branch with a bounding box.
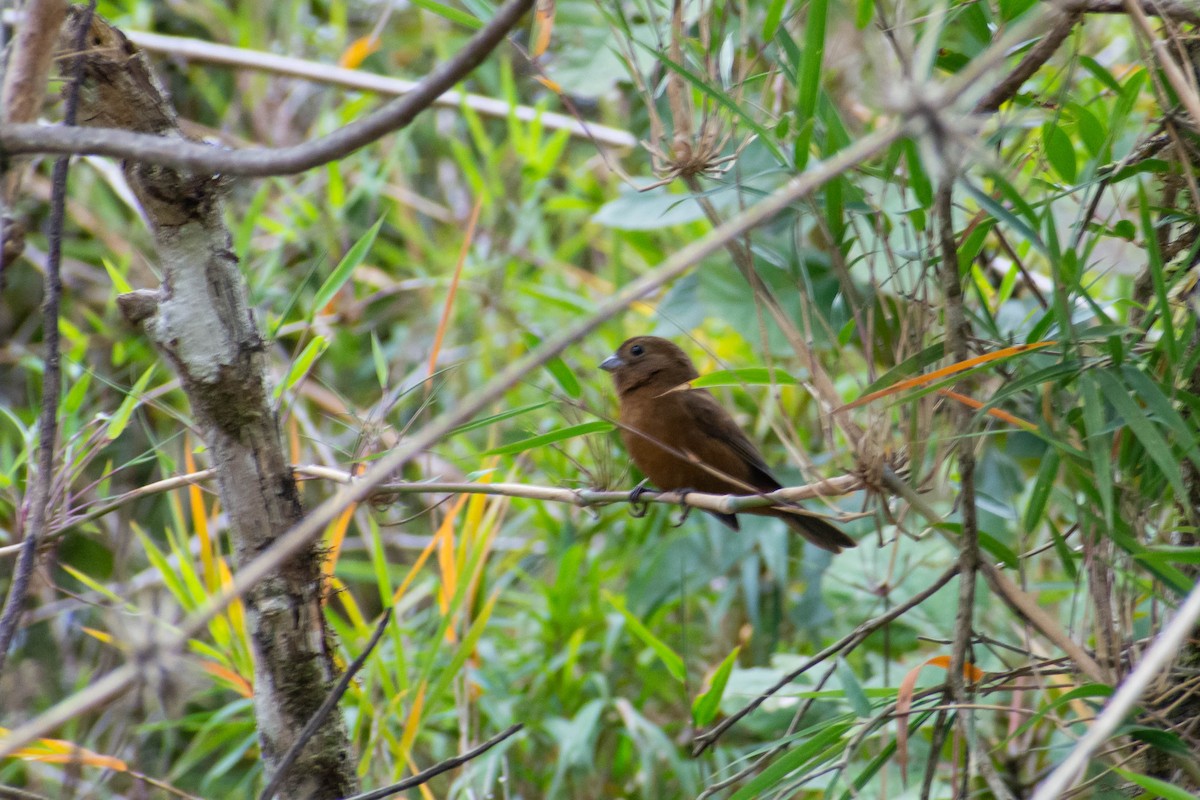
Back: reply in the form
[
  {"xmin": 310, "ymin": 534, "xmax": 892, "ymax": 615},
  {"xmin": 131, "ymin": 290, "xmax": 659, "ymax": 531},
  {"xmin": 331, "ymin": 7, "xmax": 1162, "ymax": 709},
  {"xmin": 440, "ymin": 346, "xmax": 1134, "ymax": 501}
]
[{"xmin": 600, "ymin": 336, "xmax": 856, "ymax": 553}]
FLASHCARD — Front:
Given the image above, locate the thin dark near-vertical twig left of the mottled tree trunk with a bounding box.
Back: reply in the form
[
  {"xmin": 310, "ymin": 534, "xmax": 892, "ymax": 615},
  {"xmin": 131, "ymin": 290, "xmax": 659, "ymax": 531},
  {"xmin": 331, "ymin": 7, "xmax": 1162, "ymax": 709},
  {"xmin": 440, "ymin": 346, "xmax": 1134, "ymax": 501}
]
[{"xmin": 0, "ymin": 0, "xmax": 96, "ymax": 673}]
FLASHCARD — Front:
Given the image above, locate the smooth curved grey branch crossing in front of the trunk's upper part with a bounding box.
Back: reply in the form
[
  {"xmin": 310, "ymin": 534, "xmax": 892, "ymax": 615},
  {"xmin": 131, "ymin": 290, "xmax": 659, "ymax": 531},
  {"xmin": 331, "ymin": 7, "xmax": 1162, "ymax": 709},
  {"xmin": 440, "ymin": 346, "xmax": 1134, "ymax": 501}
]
[{"xmin": 0, "ymin": 0, "xmax": 533, "ymax": 176}]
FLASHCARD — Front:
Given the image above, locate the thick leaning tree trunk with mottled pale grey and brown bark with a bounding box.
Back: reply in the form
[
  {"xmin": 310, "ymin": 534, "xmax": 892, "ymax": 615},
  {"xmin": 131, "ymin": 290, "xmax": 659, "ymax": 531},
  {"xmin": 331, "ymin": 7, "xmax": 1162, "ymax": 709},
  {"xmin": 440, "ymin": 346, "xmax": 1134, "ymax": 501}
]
[{"xmin": 60, "ymin": 13, "xmax": 358, "ymax": 800}]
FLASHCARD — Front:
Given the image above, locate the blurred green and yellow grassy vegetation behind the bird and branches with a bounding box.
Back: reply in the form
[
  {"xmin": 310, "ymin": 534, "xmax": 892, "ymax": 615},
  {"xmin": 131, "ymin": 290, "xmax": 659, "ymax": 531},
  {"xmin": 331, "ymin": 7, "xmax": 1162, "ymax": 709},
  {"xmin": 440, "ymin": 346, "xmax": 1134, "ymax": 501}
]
[{"xmin": 0, "ymin": 0, "xmax": 1200, "ymax": 799}]
